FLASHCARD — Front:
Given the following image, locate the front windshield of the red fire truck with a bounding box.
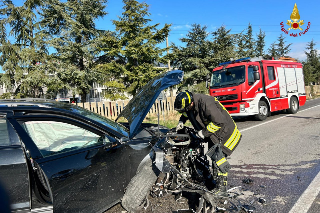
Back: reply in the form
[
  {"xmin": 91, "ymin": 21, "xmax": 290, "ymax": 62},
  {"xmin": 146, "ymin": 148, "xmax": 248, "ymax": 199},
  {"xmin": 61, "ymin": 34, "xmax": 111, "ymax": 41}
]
[{"xmin": 210, "ymin": 65, "xmax": 245, "ymax": 88}]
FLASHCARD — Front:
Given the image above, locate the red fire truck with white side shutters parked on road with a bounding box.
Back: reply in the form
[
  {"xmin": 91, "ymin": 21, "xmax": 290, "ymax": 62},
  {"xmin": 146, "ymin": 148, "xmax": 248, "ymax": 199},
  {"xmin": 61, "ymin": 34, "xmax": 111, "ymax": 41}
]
[{"xmin": 209, "ymin": 57, "xmax": 306, "ymax": 120}]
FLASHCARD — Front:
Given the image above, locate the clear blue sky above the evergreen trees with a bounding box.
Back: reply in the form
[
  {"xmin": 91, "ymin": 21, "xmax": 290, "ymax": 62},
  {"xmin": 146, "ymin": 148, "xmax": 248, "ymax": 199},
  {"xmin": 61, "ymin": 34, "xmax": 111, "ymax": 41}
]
[{"xmin": 0, "ymin": 0, "xmax": 320, "ymax": 72}]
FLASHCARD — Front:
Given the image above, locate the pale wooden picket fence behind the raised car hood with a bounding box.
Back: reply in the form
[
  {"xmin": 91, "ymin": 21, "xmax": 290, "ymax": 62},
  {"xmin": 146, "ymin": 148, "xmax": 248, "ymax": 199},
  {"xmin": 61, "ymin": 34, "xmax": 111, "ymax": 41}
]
[{"xmin": 75, "ymin": 97, "xmax": 175, "ymax": 120}]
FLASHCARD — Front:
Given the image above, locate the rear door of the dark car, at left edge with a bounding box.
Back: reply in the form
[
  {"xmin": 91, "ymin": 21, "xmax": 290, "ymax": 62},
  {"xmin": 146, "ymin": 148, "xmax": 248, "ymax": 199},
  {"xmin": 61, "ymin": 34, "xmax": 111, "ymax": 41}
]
[{"xmin": 0, "ymin": 112, "xmax": 30, "ymax": 210}]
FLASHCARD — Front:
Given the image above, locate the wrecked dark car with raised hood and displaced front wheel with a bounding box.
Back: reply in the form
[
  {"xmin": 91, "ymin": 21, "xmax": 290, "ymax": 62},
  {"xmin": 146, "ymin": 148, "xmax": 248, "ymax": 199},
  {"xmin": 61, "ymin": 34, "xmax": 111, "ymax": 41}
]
[{"xmin": 0, "ymin": 70, "xmax": 183, "ymax": 212}]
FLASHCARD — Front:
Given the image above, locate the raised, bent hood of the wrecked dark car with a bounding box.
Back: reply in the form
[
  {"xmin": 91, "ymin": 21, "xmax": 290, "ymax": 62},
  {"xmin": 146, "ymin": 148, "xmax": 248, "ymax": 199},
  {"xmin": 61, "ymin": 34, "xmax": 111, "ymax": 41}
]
[{"xmin": 116, "ymin": 70, "xmax": 183, "ymax": 139}]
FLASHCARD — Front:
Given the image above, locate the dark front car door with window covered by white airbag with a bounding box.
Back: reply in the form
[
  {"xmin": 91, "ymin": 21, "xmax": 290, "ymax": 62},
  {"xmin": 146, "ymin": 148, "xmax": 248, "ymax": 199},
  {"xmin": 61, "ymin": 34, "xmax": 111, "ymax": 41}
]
[{"xmin": 8, "ymin": 115, "xmax": 130, "ymax": 212}]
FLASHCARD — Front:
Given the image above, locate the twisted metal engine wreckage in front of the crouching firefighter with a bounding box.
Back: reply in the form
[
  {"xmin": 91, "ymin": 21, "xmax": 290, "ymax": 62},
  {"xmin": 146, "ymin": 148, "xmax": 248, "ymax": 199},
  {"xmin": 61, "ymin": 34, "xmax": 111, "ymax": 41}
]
[{"xmin": 151, "ymin": 127, "xmax": 265, "ymax": 213}]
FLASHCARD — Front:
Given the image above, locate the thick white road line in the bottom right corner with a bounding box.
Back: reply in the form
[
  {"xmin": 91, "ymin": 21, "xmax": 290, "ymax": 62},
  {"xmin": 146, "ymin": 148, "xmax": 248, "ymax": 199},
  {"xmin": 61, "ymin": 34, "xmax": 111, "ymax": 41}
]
[{"xmin": 289, "ymin": 172, "xmax": 320, "ymax": 213}]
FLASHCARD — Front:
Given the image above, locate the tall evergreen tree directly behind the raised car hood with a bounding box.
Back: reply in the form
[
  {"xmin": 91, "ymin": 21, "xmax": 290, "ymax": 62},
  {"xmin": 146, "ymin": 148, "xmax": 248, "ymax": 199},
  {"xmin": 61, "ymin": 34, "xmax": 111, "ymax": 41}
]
[{"xmin": 99, "ymin": 0, "xmax": 170, "ymax": 95}]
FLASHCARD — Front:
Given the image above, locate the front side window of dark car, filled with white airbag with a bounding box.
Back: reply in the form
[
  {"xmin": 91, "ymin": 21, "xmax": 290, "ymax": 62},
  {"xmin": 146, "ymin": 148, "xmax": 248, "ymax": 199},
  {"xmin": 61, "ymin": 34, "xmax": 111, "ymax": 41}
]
[{"xmin": 23, "ymin": 121, "xmax": 108, "ymax": 157}]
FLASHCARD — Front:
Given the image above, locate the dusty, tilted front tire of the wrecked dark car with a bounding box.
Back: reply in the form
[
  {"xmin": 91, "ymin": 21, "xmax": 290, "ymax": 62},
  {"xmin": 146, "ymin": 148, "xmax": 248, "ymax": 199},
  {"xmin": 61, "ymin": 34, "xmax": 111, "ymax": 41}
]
[{"xmin": 121, "ymin": 155, "xmax": 157, "ymax": 212}]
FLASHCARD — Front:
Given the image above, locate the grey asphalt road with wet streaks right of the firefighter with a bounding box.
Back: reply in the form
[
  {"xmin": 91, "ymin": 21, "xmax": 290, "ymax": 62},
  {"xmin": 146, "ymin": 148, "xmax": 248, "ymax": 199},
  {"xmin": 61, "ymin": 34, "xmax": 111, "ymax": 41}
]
[{"xmin": 229, "ymin": 99, "xmax": 320, "ymax": 213}]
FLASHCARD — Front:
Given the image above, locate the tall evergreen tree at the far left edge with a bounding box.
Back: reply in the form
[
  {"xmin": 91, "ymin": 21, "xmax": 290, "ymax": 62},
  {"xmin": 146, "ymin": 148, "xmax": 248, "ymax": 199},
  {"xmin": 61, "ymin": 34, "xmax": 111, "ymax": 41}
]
[{"xmin": 0, "ymin": 0, "xmax": 48, "ymax": 97}]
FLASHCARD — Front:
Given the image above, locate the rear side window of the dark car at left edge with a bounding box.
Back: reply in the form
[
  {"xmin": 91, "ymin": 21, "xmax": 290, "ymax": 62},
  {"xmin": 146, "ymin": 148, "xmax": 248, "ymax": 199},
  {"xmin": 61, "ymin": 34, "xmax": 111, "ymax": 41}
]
[{"xmin": 0, "ymin": 115, "xmax": 20, "ymax": 146}]
